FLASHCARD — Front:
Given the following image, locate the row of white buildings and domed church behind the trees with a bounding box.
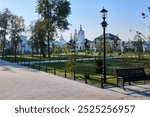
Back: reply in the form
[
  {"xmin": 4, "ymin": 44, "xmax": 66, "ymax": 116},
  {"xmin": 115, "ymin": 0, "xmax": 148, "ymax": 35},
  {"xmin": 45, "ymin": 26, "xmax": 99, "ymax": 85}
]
[{"xmin": 17, "ymin": 25, "xmax": 150, "ymax": 53}]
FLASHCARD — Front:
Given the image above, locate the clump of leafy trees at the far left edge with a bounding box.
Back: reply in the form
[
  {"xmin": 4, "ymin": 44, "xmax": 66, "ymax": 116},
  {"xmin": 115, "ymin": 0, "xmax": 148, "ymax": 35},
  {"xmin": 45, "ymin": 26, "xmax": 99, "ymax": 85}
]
[{"xmin": 0, "ymin": 8, "xmax": 24, "ymax": 60}]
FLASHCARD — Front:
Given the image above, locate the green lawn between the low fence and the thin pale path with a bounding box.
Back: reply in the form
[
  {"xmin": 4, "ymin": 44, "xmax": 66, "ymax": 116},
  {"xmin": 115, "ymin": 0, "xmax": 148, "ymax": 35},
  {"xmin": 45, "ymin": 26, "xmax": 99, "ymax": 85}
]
[{"xmin": 28, "ymin": 58, "xmax": 150, "ymax": 86}]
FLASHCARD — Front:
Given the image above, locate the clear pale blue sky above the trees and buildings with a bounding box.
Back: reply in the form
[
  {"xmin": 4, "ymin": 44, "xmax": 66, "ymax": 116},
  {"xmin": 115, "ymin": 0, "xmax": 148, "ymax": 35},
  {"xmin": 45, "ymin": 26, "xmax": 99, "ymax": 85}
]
[{"xmin": 0, "ymin": 0, "xmax": 150, "ymax": 41}]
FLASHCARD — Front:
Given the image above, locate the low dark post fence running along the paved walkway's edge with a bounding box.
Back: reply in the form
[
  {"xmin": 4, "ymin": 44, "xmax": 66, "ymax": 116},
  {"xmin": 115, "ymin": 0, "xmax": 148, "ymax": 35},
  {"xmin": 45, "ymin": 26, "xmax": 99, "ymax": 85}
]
[{"xmin": 18, "ymin": 62, "xmax": 114, "ymax": 88}]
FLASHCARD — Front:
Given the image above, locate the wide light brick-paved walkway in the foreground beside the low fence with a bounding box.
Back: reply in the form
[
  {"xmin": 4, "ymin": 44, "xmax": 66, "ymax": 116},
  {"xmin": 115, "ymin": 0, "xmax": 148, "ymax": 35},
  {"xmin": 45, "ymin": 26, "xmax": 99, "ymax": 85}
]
[{"xmin": 0, "ymin": 60, "xmax": 150, "ymax": 100}]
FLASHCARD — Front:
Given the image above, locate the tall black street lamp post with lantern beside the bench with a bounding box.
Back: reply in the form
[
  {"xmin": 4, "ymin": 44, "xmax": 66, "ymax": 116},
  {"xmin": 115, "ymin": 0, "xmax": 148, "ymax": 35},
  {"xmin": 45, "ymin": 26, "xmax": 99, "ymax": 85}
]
[{"xmin": 100, "ymin": 8, "xmax": 108, "ymax": 83}]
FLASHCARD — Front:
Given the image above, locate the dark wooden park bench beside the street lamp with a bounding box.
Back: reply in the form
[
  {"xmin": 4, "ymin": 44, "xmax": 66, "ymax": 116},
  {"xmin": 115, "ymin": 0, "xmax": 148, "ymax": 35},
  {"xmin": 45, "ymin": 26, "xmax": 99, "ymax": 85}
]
[{"xmin": 115, "ymin": 68, "xmax": 150, "ymax": 90}]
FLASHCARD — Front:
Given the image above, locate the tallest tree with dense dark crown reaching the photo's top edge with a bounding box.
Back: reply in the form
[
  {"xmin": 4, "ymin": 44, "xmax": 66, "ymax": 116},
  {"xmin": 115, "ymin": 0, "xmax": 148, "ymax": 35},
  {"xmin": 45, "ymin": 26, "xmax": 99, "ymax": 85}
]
[{"xmin": 37, "ymin": 0, "xmax": 71, "ymax": 58}]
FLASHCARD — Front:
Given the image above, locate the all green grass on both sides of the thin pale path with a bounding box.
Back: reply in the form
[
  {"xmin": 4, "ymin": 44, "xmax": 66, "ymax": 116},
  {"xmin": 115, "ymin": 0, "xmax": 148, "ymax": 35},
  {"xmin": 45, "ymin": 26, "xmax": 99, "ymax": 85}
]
[{"xmin": 3, "ymin": 53, "xmax": 150, "ymax": 86}]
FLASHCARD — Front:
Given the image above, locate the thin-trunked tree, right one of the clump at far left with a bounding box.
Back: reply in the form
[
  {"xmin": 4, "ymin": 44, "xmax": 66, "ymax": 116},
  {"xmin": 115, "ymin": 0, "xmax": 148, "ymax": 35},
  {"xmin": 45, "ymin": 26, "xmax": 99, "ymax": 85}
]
[{"xmin": 10, "ymin": 15, "xmax": 24, "ymax": 62}]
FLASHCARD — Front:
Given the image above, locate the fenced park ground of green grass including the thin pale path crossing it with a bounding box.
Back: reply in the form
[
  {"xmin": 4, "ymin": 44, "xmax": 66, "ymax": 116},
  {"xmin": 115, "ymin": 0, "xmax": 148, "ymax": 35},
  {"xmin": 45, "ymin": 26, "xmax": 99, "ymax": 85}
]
[{"xmin": 3, "ymin": 53, "xmax": 150, "ymax": 87}]
